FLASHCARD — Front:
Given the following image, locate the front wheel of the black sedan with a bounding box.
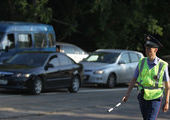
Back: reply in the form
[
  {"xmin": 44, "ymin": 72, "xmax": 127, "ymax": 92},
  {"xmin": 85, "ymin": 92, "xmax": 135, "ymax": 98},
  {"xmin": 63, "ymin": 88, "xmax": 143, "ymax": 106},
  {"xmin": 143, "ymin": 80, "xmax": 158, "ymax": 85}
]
[{"xmin": 30, "ymin": 77, "xmax": 43, "ymax": 95}]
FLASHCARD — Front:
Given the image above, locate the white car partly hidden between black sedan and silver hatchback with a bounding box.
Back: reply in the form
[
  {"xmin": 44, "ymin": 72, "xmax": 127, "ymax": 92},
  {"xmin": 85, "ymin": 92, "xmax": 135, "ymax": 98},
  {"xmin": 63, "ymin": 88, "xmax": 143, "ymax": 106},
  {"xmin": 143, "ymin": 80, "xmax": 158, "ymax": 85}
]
[{"xmin": 56, "ymin": 42, "xmax": 89, "ymax": 63}]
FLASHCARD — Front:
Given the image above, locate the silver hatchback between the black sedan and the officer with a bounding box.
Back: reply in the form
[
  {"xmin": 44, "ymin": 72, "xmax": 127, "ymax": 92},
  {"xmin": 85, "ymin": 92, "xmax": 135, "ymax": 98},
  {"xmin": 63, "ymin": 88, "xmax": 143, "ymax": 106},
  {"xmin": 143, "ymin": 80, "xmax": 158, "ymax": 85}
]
[{"xmin": 81, "ymin": 49, "xmax": 143, "ymax": 88}]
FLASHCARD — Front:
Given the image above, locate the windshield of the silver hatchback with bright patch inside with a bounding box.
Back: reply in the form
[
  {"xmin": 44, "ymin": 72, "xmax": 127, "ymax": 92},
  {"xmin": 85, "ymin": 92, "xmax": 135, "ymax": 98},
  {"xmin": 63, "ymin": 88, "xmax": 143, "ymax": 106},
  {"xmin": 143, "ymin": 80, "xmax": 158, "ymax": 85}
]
[{"xmin": 83, "ymin": 52, "xmax": 120, "ymax": 63}]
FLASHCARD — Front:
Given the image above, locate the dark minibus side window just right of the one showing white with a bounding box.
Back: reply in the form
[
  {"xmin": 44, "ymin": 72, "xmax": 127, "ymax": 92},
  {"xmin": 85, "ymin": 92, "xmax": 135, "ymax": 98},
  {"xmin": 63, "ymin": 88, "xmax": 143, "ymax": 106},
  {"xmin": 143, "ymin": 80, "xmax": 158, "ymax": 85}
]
[{"xmin": 34, "ymin": 33, "xmax": 47, "ymax": 48}]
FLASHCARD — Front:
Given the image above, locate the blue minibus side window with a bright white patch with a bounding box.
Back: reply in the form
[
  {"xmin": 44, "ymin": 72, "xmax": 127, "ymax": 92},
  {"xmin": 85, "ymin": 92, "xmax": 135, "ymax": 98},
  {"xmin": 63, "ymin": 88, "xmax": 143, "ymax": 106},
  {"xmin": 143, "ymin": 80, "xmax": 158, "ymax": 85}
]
[{"xmin": 18, "ymin": 34, "xmax": 32, "ymax": 48}]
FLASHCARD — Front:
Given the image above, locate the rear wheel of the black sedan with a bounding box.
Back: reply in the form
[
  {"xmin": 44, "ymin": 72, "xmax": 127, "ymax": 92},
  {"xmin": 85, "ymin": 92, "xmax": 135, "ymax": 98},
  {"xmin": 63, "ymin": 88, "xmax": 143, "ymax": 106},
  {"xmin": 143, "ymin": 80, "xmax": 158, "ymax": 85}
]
[{"xmin": 68, "ymin": 76, "xmax": 80, "ymax": 93}]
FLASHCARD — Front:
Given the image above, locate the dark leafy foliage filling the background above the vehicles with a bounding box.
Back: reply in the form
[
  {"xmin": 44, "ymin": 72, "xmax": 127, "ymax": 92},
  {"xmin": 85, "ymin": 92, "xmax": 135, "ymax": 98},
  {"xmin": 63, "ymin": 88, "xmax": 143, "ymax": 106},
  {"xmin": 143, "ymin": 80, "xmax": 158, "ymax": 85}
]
[{"xmin": 0, "ymin": 0, "xmax": 170, "ymax": 54}]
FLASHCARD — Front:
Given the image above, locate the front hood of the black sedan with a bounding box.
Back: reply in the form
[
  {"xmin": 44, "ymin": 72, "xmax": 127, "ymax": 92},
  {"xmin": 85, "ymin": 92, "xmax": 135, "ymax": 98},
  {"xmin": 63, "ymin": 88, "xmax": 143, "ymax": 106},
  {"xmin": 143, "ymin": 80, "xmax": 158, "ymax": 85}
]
[{"xmin": 0, "ymin": 64, "xmax": 39, "ymax": 73}]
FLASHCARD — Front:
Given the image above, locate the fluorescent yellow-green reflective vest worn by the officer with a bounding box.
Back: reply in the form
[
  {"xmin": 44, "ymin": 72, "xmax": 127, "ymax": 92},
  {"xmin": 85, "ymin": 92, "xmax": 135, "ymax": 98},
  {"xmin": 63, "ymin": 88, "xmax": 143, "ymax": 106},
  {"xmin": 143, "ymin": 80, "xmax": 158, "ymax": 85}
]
[{"xmin": 137, "ymin": 57, "xmax": 168, "ymax": 100}]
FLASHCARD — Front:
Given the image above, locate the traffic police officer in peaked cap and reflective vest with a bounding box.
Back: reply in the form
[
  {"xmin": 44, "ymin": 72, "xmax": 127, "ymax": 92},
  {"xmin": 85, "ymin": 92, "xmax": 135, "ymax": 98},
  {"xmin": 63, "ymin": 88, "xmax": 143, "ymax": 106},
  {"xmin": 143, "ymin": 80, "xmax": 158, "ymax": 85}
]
[{"xmin": 122, "ymin": 35, "xmax": 170, "ymax": 120}]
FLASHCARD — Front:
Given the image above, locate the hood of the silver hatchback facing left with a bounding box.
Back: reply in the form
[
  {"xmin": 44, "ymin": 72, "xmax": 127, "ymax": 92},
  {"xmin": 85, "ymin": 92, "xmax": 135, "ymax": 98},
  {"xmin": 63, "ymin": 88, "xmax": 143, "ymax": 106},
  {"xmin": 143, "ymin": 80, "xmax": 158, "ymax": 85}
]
[{"xmin": 81, "ymin": 62, "xmax": 114, "ymax": 70}]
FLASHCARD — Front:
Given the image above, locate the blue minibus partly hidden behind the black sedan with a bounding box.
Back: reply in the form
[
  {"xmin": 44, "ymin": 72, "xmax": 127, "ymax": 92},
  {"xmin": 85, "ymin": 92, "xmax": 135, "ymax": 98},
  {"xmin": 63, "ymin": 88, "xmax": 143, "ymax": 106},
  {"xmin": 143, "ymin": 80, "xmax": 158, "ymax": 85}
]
[{"xmin": 0, "ymin": 21, "xmax": 56, "ymax": 63}]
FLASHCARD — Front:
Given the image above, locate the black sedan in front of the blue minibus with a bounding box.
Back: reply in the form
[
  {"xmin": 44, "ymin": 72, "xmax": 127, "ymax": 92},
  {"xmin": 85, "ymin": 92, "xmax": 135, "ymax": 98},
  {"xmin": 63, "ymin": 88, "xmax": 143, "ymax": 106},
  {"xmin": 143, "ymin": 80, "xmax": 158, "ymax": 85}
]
[{"xmin": 0, "ymin": 51, "xmax": 82, "ymax": 95}]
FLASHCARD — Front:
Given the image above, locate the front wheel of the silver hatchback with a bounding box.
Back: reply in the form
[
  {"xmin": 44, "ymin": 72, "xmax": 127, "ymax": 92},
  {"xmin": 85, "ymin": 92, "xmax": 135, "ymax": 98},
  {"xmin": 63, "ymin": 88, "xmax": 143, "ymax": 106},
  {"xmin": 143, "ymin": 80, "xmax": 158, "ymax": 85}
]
[{"xmin": 107, "ymin": 74, "xmax": 116, "ymax": 88}]
